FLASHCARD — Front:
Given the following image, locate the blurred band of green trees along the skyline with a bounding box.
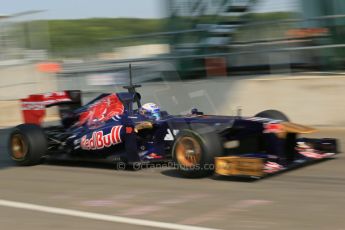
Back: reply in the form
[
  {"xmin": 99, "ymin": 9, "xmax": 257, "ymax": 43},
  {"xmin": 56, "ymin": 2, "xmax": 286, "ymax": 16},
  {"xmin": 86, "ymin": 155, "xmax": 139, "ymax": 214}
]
[{"xmin": 11, "ymin": 12, "xmax": 296, "ymax": 57}]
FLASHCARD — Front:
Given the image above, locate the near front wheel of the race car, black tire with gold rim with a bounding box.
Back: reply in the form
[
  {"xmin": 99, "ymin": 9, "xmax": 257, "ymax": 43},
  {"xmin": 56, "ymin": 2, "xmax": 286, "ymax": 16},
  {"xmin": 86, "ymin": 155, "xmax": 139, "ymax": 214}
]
[{"xmin": 172, "ymin": 129, "xmax": 223, "ymax": 178}]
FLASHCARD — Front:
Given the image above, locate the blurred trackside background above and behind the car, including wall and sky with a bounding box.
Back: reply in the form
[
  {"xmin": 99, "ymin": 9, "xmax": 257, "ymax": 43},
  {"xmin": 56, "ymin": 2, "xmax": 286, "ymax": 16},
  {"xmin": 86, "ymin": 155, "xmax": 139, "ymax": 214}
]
[{"xmin": 0, "ymin": 0, "xmax": 345, "ymax": 126}]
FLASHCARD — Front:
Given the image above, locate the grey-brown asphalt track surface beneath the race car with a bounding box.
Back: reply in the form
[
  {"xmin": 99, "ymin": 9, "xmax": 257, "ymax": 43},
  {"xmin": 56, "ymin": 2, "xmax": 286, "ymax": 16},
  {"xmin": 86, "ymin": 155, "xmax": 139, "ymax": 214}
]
[{"xmin": 0, "ymin": 128, "xmax": 345, "ymax": 230}]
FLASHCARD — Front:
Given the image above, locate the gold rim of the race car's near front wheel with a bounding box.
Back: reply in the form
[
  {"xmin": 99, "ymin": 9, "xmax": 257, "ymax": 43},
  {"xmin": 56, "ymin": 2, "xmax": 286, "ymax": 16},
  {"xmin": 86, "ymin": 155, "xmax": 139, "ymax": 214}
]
[{"xmin": 176, "ymin": 137, "xmax": 202, "ymax": 167}]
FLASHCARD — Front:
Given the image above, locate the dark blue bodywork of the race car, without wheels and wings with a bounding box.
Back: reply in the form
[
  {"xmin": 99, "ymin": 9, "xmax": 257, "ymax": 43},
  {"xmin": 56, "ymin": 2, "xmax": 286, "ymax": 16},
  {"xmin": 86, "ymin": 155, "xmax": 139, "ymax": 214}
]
[{"xmin": 43, "ymin": 92, "xmax": 337, "ymax": 172}]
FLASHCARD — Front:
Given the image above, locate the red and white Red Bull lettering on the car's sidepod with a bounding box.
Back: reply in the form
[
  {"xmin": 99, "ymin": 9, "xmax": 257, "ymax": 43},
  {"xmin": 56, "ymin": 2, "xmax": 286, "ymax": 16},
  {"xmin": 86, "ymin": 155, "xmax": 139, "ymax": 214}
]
[{"xmin": 80, "ymin": 125, "xmax": 122, "ymax": 150}]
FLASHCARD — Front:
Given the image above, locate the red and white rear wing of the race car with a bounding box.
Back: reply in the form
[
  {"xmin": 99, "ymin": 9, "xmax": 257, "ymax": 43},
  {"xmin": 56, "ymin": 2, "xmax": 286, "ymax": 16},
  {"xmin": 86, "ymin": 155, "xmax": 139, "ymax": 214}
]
[{"xmin": 20, "ymin": 90, "xmax": 81, "ymax": 125}]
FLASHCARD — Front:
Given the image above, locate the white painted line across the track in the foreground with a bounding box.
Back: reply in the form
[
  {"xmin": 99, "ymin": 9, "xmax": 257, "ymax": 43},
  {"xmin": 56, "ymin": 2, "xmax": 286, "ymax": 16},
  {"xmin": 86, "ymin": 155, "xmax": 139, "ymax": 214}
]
[{"xmin": 0, "ymin": 199, "xmax": 220, "ymax": 230}]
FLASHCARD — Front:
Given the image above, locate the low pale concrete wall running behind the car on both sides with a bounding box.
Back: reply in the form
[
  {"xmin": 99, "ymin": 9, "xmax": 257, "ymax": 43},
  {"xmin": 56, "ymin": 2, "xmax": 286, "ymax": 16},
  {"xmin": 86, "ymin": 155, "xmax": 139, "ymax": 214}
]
[{"xmin": 0, "ymin": 63, "xmax": 345, "ymax": 126}]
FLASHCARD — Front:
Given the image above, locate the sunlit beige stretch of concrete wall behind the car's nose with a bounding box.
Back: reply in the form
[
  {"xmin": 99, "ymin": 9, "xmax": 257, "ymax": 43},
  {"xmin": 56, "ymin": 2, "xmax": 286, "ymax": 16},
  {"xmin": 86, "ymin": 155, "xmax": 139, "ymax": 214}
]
[{"xmin": 226, "ymin": 75, "xmax": 345, "ymax": 126}]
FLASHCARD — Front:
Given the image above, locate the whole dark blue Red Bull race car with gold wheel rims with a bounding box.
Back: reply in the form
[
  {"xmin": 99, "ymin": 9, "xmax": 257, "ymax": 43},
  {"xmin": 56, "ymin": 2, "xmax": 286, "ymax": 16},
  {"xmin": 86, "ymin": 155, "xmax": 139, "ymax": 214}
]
[{"xmin": 9, "ymin": 76, "xmax": 338, "ymax": 178}]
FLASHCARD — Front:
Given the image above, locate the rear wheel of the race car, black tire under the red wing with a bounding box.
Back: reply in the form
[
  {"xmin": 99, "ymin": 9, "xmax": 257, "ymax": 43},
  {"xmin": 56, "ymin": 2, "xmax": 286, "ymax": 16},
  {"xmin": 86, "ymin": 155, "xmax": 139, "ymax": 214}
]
[{"xmin": 8, "ymin": 124, "xmax": 48, "ymax": 166}]
